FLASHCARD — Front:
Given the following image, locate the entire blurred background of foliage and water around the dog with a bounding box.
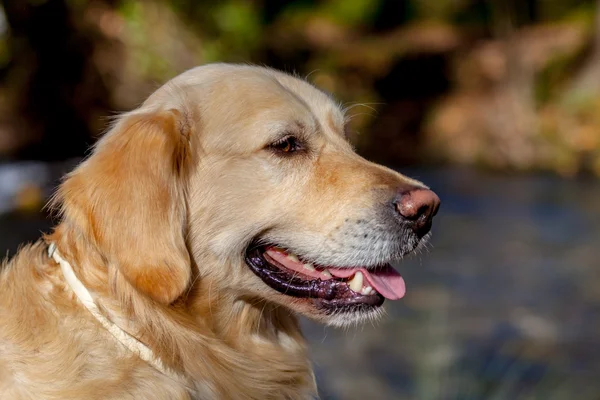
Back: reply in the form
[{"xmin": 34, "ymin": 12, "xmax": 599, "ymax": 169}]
[{"xmin": 0, "ymin": 0, "xmax": 600, "ymax": 400}]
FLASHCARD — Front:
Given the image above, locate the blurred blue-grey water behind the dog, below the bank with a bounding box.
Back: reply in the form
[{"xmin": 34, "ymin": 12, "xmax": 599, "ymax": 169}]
[{"xmin": 0, "ymin": 168, "xmax": 600, "ymax": 400}]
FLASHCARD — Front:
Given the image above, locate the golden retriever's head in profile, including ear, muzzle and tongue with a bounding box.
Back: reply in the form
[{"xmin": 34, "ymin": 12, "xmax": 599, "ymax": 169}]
[{"xmin": 56, "ymin": 64, "xmax": 439, "ymax": 325}]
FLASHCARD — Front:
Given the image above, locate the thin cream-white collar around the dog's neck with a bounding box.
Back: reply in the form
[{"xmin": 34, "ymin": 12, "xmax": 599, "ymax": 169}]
[{"xmin": 48, "ymin": 243, "xmax": 181, "ymax": 381}]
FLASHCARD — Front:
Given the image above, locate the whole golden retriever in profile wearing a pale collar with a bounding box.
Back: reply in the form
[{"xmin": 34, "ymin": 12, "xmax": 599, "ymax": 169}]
[{"xmin": 0, "ymin": 64, "xmax": 440, "ymax": 400}]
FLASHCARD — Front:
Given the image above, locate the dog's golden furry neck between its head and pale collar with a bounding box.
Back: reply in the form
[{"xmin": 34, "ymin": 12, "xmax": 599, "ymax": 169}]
[{"xmin": 47, "ymin": 226, "xmax": 315, "ymax": 399}]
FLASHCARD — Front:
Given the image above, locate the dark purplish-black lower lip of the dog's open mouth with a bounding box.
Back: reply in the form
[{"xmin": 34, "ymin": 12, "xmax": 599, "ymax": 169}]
[{"xmin": 246, "ymin": 245, "xmax": 385, "ymax": 310}]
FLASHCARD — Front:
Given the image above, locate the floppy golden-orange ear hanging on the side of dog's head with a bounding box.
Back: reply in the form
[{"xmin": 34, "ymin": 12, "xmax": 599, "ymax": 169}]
[{"xmin": 59, "ymin": 110, "xmax": 194, "ymax": 304}]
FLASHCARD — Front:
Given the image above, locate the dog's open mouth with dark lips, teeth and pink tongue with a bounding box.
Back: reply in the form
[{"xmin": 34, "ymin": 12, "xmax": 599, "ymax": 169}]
[{"xmin": 246, "ymin": 241, "xmax": 405, "ymax": 311}]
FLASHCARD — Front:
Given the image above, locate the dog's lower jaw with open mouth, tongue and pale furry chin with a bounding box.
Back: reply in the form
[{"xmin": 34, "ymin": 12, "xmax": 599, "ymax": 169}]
[{"xmin": 245, "ymin": 239, "xmax": 418, "ymax": 326}]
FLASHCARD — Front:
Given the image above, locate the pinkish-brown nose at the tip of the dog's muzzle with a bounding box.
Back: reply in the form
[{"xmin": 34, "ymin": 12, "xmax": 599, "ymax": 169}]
[{"xmin": 394, "ymin": 188, "xmax": 440, "ymax": 237}]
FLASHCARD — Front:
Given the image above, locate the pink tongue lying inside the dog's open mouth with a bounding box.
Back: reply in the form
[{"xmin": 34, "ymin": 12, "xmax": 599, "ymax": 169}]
[{"xmin": 265, "ymin": 248, "xmax": 406, "ymax": 300}]
